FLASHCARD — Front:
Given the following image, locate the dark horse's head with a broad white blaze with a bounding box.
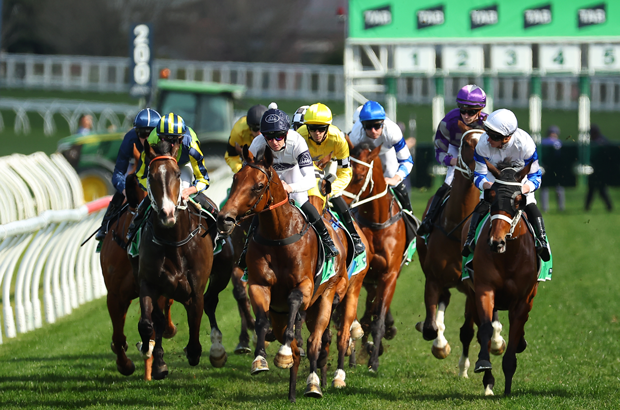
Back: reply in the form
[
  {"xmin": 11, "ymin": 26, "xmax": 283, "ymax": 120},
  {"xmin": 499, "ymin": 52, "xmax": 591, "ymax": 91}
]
[{"xmin": 144, "ymin": 140, "xmax": 181, "ymax": 228}]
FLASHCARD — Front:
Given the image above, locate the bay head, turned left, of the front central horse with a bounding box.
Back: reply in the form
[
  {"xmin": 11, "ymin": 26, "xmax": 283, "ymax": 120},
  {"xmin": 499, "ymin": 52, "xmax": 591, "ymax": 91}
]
[{"xmin": 217, "ymin": 145, "xmax": 286, "ymax": 235}]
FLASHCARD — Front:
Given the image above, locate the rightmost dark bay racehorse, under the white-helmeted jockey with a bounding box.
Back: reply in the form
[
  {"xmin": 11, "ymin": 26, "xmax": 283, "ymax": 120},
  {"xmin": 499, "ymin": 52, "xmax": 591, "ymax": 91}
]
[{"xmin": 463, "ymin": 159, "xmax": 538, "ymax": 395}]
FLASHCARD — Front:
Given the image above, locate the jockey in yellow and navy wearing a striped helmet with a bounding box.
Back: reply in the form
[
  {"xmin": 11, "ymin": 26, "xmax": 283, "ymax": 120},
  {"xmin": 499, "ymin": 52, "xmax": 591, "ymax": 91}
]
[{"xmin": 127, "ymin": 113, "xmax": 213, "ymax": 242}]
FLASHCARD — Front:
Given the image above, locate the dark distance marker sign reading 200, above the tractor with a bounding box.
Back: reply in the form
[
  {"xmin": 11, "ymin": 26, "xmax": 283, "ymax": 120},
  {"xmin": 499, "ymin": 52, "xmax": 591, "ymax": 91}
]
[{"xmin": 129, "ymin": 24, "xmax": 152, "ymax": 97}]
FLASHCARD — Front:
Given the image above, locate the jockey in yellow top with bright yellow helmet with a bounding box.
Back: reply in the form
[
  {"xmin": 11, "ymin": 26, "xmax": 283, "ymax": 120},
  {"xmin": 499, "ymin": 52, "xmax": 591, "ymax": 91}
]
[{"xmin": 297, "ymin": 103, "xmax": 365, "ymax": 256}]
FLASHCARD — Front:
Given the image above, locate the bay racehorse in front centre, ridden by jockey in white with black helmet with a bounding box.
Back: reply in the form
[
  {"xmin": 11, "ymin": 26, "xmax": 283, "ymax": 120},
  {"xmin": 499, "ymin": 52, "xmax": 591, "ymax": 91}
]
[{"xmin": 217, "ymin": 145, "xmax": 348, "ymax": 402}]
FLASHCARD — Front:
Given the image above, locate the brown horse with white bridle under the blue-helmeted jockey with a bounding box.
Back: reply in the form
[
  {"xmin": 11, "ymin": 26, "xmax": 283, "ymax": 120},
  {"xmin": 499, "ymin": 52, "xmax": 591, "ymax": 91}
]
[{"xmin": 345, "ymin": 141, "xmax": 407, "ymax": 372}]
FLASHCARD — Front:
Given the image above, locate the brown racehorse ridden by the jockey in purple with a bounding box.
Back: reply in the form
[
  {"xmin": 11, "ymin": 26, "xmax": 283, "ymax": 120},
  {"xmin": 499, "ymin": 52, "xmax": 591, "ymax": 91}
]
[{"xmin": 416, "ymin": 128, "xmax": 506, "ymax": 377}]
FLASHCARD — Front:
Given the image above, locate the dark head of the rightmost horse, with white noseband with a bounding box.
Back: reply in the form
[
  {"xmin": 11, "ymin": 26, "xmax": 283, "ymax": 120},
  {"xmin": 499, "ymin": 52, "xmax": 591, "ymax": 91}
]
[{"xmin": 484, "ymin": 159, "xmax": 531, "ymax": 253}]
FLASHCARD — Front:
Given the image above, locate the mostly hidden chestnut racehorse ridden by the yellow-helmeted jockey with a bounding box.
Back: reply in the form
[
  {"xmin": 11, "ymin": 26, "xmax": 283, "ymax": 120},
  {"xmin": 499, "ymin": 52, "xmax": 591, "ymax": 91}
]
[{"xmin": 308, "ymin": 155, "xmax": 369, "ymax": 388}]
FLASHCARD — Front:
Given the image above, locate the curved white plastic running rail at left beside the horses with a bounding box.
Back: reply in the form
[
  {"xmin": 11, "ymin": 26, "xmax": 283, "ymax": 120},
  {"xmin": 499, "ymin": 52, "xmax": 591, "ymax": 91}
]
[{"xmin": 0, "ymin": 153, "xmax": 110, "ymax": 343}]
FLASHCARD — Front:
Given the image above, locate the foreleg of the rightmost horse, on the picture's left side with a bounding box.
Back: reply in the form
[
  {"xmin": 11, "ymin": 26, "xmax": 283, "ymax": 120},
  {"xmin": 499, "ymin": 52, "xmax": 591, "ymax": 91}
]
[{"xmin": 474, "ymin": 286, "xmax": 495, "ymax": 396}]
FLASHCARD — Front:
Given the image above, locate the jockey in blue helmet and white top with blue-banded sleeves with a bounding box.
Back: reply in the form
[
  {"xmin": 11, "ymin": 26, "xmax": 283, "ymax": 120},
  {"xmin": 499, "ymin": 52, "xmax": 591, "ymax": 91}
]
[{"xmin": 349, "ymin": 101, "xmax": 413, "ymax": 214}]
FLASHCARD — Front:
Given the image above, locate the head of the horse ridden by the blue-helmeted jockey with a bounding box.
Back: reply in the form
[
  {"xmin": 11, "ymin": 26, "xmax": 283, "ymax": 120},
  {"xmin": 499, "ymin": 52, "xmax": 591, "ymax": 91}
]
[{"xmin": 343, "ymin": 137, "xmax": 383, "ymax": 204}]
